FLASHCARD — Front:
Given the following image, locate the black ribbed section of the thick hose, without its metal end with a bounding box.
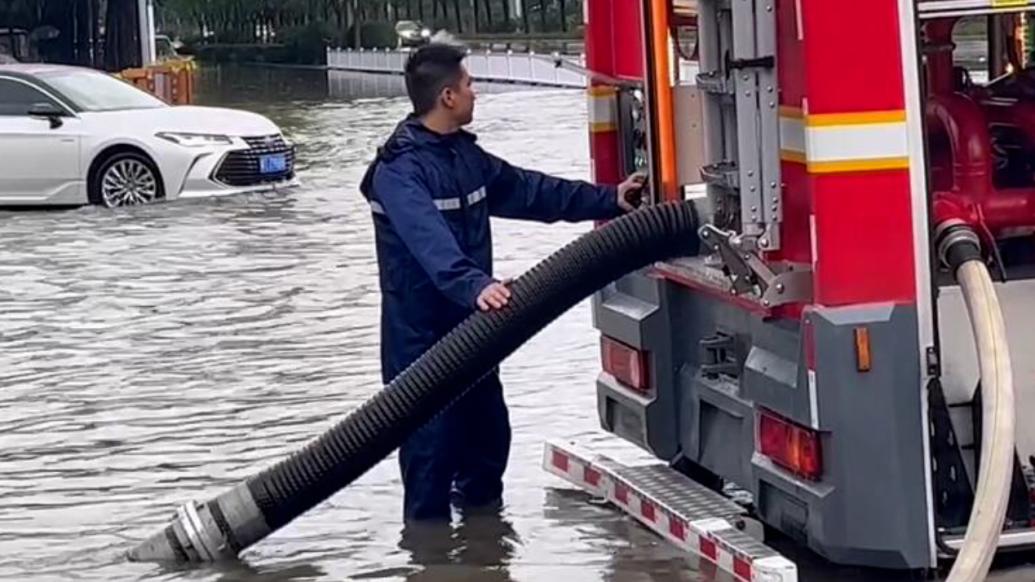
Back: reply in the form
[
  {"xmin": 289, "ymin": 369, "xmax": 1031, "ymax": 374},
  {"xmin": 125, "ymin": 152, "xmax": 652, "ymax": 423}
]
[{"xmin": 247, "ymin": 198, "xmax": 699, "ymax": 530}]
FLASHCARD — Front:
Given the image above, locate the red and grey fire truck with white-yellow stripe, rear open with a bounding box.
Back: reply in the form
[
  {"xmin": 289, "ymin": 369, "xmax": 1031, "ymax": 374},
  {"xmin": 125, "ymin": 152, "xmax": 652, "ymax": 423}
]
[{"xmin": 544, "ymin": 0, "xmax": 1035, "ymax": 580}]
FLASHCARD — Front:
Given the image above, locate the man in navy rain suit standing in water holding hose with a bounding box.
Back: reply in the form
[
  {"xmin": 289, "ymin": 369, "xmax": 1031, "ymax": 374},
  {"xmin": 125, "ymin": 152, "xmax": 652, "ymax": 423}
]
[{"xmin": 360, "ymin": 43, "xmax": 642, "ymax": 522}]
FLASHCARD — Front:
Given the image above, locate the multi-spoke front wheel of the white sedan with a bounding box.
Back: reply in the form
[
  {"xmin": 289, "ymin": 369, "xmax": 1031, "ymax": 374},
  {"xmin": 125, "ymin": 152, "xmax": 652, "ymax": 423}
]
[{"xmin": 90, "ymin": 151, "xmax": 165, "ymax": 208}]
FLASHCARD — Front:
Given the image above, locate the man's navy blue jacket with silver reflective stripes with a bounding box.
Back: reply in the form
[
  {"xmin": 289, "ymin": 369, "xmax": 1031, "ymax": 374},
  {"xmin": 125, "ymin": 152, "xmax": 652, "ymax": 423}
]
[{"xmin": 360, "ymin": 115, "xmax": 621, "ymax": 383}]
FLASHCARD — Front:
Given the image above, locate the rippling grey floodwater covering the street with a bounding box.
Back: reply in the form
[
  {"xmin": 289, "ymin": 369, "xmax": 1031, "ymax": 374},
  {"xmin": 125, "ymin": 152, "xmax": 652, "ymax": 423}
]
[{"xmin": 6, "ymin": 63, "xmax": 1031, "ymax": 582}]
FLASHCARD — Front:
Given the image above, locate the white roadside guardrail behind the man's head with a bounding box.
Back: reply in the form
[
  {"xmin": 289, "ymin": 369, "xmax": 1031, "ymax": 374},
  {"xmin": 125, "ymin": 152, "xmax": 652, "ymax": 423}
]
[{"xmin": 327, "ymin": 49, "xmax": 587, "ymax": 89}]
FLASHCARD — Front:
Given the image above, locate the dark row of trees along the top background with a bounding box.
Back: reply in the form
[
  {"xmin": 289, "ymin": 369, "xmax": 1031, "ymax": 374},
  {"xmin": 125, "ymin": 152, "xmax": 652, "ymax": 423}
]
[{"xmin": 0, "ymin": 0, "xmax": 583, "ymax": 70}]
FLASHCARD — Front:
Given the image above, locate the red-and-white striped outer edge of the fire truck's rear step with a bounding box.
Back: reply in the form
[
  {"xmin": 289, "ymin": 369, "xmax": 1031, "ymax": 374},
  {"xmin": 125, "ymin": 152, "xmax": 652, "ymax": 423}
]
[{"xmin": 543, "ymin": 442, "xmax": 798, "ymax": 582}]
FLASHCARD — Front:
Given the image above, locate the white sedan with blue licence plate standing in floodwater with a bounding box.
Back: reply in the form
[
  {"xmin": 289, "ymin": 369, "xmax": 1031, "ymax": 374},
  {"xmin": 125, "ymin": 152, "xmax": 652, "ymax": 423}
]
[{"xmin": 0, "ymin": 64, "xmax": 296, "ymax": 207}]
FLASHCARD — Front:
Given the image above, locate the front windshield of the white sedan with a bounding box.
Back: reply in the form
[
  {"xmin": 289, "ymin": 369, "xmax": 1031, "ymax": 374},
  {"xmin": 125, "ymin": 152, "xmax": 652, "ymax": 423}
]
[{"xmin": 40, "ymin": 70, "xmax": 168, "ymax": 111}]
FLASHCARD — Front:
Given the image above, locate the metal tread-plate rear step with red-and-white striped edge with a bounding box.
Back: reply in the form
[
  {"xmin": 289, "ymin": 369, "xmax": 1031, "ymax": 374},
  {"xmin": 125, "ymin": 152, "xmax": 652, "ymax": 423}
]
[{"xmin": 542, "ymin": 441, "xmax": 798, "ymax": 582}]
